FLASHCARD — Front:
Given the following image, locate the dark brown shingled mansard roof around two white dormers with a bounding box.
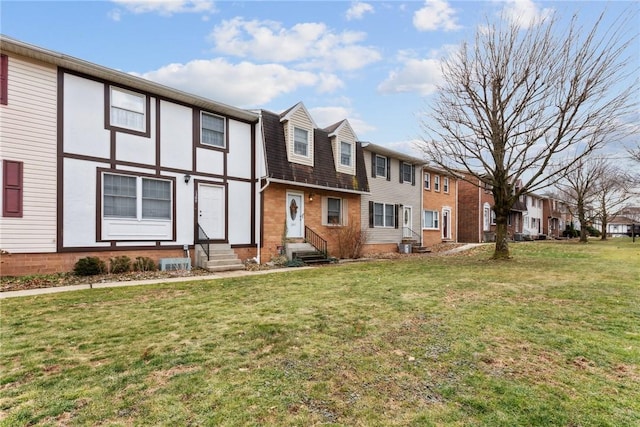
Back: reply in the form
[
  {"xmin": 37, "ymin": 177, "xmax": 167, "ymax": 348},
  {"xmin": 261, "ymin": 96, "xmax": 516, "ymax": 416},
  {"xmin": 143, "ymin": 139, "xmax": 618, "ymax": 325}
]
[{"xmin": 261, "ymin": 108, "xmax": 369, "ymax": 193}]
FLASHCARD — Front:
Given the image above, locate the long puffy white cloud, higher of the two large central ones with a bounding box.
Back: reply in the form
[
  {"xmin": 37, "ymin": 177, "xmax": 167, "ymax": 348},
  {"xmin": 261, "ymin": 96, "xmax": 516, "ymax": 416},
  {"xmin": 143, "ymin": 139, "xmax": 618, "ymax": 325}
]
[{"xmin": 210, "ymin": 18, "xmax": 381, "ymax": 70}]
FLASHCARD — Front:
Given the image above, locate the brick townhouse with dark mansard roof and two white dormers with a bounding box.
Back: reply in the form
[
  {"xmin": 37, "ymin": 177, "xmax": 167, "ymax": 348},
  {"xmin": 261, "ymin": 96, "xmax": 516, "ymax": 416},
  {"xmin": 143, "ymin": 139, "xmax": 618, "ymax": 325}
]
[{"xmin": 258, "ymin": 102, "xmax": 369, "ymax": 262}]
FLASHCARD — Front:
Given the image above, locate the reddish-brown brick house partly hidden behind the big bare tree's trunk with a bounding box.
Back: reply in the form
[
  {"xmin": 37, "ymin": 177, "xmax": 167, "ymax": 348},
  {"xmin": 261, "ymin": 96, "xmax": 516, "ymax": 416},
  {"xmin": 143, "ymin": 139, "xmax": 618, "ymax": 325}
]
[{"xmin": 458, "ymin": 179, "xmax": 527, "ymax": 243}]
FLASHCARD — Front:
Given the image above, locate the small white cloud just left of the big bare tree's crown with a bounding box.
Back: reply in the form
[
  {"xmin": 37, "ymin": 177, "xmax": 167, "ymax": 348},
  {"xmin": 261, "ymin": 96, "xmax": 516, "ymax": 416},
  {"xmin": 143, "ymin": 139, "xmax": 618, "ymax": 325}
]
[{"xmin": 378, "ymin": 58, "xmax": 442, "ymax": 96}]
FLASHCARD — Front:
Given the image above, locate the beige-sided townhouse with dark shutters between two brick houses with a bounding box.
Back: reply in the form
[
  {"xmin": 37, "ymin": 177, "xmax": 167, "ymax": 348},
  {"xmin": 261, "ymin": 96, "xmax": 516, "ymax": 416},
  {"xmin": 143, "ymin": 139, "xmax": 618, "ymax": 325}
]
[{"xmin": 360, "ymin": 142, "xmax": 424, "ymax": 253}]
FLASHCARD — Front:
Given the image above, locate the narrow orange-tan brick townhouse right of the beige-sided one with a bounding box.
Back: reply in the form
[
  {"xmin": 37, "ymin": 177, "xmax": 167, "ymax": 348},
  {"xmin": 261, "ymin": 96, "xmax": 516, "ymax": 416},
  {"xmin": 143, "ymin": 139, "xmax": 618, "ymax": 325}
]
[{"xmin": 422, "ymin": 166, "xmax": 458, "ymax": 247}]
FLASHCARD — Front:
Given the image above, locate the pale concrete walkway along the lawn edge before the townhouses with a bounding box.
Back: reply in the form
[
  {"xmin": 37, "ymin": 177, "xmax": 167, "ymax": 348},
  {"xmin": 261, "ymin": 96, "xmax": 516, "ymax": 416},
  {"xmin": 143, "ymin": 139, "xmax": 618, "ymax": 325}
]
[{"xmin": 0, "ymin": 243, "xmax": 483, "ymax": 299}]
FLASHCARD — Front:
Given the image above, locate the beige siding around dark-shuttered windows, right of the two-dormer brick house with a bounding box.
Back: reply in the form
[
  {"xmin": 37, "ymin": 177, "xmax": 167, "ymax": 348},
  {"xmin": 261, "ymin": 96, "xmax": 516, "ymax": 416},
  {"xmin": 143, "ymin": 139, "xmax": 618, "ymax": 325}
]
[{"xmin": 361, "ymin": 149, "xmax": 422, "ymax": 244}]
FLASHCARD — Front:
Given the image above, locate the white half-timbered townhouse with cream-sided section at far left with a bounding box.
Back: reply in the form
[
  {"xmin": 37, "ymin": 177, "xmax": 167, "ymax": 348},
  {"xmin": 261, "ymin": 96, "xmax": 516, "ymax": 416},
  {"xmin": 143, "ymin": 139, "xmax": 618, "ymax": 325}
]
[{"xmin": 0, "ymin": 36, "xmax": 259, "ymax": 275}]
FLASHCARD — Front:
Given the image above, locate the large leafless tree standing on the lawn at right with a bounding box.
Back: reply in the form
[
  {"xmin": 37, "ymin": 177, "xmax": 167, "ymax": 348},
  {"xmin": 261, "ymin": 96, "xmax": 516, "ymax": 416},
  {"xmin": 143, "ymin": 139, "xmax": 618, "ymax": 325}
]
[{"xmin": 419, "ymin": 11, "xmax": 638, "ymax": 259}]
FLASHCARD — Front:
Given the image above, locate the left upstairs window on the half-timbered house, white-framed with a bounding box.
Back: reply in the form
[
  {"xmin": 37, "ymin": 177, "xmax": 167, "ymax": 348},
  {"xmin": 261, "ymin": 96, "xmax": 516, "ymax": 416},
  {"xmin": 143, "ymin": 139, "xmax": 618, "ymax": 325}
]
[{"xmin": 109, "ymin": 86, "xmax": 148, "ymax": 132}]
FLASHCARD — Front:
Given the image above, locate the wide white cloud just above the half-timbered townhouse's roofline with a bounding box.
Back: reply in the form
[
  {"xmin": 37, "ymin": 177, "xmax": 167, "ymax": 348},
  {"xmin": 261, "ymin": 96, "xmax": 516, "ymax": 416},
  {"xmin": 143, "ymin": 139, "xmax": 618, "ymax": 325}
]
[{"xmin": 136, "ymin": 58, "xmax": 324, "ymax": 108}]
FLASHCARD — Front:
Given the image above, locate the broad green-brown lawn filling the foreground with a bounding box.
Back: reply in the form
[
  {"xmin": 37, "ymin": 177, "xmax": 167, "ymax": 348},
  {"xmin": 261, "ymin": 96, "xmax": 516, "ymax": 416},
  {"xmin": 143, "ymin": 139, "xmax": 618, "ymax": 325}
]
[{"xmin": 0, "ymin": 239, "xmax": 640, "ymax": 426}]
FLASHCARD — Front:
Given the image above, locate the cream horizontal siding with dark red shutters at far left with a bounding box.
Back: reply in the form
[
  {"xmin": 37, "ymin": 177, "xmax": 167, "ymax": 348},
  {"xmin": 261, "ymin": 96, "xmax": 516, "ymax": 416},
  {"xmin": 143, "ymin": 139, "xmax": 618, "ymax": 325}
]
[{"xmin": 0, "ymin": 55, "xmax": 57, "ymax": 253}]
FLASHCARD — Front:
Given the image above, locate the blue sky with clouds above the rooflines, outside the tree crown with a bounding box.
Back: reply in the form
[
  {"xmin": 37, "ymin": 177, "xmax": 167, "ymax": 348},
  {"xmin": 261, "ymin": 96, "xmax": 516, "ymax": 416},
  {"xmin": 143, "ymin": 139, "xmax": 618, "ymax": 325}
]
[{"xmin": 0, "ymin": 0, "xmax": 640, "ymax": 160}]
